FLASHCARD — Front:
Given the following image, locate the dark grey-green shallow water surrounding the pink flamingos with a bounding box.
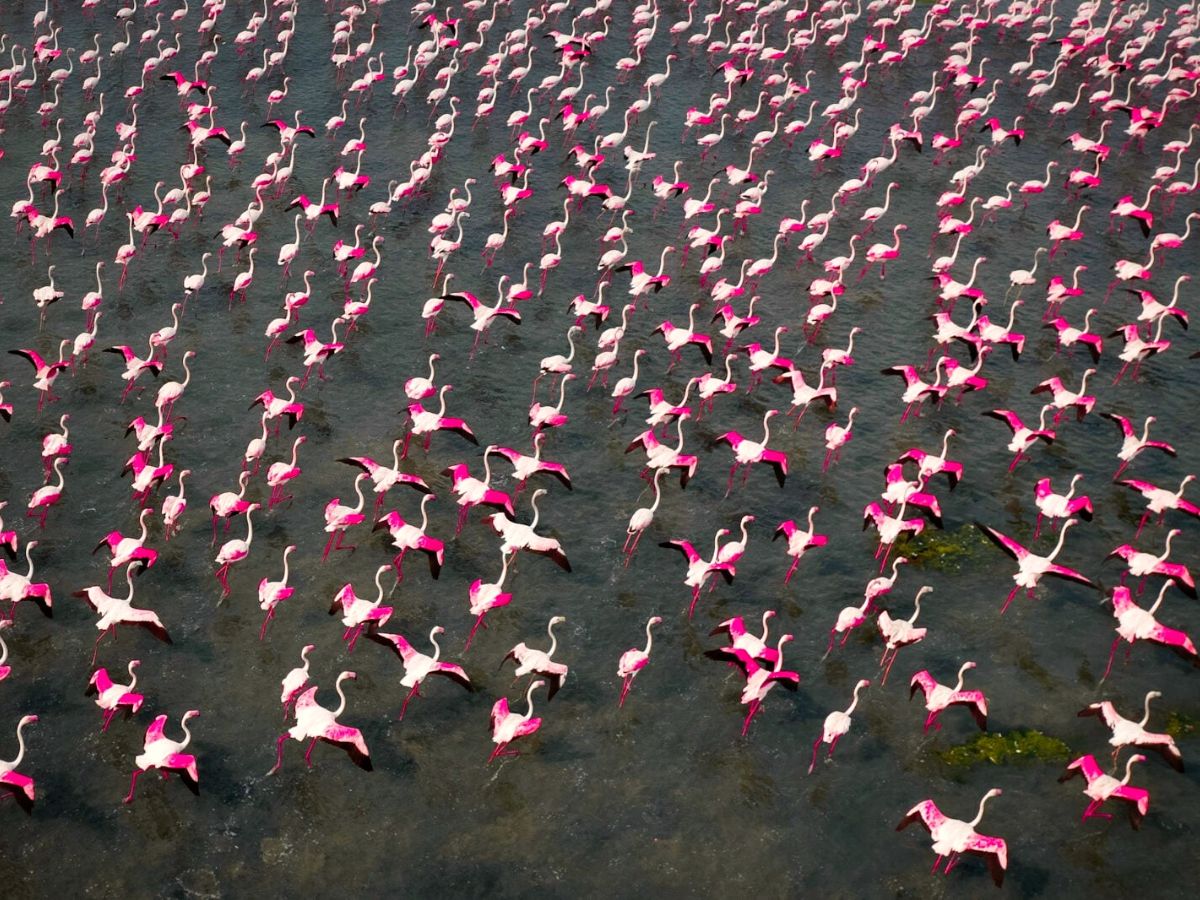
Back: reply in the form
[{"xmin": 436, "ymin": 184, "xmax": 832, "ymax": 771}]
[{"xmin": 0, "ymin": 1, "xmax": 1200, "ymax": 896}]
